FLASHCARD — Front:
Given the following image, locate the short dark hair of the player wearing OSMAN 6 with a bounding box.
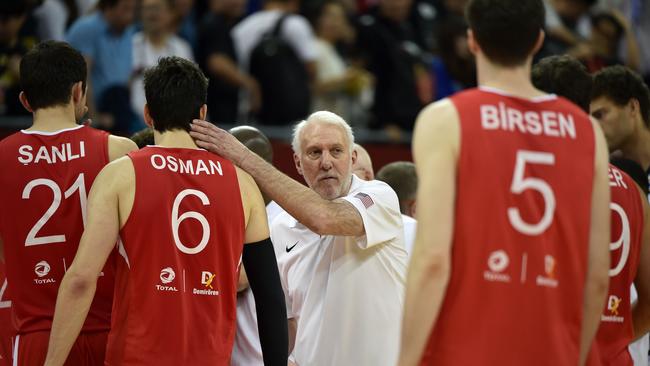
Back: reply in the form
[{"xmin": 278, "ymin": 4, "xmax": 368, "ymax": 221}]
[{"xmin": 144, "ymin": 56, "xmax": 208, "ymax": 132}]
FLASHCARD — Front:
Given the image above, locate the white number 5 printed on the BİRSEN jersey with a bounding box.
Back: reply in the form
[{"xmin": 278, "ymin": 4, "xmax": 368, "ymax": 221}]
[{"xmin": 508, "ymin": 150, "xmax": 556, "ymax": 236}]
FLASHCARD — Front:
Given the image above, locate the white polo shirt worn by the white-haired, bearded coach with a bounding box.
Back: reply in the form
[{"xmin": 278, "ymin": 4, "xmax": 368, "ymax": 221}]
[{"xmin": 271, "ymin": 176, "xmax": 407, "ymax": 366}]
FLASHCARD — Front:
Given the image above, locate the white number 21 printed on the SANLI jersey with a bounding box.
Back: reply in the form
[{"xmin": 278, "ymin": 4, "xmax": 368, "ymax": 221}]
[{"xmin": 22, "ymin": 173, "xmax": 88, "ymax": 246}]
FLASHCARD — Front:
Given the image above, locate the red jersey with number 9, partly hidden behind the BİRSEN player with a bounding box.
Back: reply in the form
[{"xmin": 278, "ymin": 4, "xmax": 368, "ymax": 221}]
[{"xmin": 596, "ymin": 165, "xmax": 644, "ymax": 365}]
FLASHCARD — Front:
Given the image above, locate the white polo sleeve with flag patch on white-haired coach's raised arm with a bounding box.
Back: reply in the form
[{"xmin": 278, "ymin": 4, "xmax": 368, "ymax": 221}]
[{"xmin": 342, "ymin": 180, "xmax": 404, "ymax": 249}]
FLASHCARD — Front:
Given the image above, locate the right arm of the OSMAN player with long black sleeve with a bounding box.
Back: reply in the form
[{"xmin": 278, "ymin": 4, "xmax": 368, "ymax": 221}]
[{"xmin": 237, "ymin": 168, "xmax": 289, "ymax": 366}]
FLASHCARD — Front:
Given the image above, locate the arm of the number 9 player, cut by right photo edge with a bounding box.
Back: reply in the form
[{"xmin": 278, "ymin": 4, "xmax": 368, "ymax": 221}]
[{"xmin": 632, "ymin": 187, "xmax": 650, "ymax": 340}]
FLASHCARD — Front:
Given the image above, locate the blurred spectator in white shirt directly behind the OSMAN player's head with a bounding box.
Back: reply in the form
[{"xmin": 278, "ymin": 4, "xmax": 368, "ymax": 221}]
[{"xmin": 129, "ymin": 0, "xmax": 194, "ymax": 133}]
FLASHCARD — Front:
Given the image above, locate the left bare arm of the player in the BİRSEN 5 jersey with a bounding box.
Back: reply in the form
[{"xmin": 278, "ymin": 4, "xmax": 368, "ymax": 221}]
[{"xmin": 398, "ymin": 100, "xmax": 460, "ymax": 366}]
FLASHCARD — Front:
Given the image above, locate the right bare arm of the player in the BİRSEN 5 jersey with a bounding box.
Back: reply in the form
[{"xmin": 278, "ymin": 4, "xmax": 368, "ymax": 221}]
[{"xmin": 580, "ymin": 121, "xmax": 611, "ymax": 365}]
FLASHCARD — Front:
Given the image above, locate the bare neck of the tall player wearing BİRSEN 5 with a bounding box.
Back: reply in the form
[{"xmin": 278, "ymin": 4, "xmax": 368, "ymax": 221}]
[{"xmin": 477, "ymin": 57, "xmax": 545, "ymax": 99}]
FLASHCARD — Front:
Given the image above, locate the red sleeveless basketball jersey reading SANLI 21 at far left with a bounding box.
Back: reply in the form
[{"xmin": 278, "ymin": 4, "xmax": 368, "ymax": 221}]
[{"xmin": 0, "ymin": 126, "xmax": 114, "ymax": 334}]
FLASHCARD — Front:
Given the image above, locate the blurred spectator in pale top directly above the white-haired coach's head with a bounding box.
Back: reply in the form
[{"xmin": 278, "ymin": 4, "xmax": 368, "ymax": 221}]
[{"xmin": 312, "ymin": 0, "xmax": 370, "ymax": 124}]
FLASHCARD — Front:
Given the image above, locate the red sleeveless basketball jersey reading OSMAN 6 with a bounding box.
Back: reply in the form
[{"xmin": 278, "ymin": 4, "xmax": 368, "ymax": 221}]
[{"xmin": 106, "ymin": 146, "xmax": 245, "ymax": 366}]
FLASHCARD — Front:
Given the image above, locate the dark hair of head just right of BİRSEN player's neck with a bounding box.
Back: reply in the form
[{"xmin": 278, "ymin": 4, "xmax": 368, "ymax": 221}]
[{"xmin": 532, "ymin": 55, "xmax": 593, "ymax": 113}]
